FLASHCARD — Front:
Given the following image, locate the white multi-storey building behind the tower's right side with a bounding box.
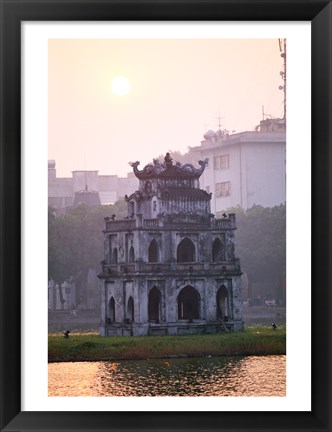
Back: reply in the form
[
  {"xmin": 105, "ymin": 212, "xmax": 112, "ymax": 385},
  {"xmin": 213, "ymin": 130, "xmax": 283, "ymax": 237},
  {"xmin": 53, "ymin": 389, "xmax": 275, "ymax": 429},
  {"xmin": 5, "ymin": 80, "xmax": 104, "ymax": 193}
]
[{"xmin": 191, "ymin": 119, "xmax": 286, "ymax": 215}]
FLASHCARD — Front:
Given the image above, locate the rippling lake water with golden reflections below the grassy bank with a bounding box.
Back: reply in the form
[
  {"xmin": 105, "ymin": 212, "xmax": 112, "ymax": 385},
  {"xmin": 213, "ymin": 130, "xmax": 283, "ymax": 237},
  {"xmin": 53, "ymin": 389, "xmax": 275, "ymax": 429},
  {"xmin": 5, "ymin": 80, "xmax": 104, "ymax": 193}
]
[{"xmin": 49, "ymin": 356, "xmax": 286, "ymax": 396}]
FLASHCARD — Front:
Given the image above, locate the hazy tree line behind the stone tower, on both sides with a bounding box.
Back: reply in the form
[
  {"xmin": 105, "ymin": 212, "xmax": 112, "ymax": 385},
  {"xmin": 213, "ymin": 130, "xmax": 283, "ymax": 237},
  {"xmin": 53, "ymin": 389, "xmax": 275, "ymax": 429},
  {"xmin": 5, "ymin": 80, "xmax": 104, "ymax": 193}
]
[{"xmin": 48, "ymin": 200, "xmax": 286, "ymax": 304}]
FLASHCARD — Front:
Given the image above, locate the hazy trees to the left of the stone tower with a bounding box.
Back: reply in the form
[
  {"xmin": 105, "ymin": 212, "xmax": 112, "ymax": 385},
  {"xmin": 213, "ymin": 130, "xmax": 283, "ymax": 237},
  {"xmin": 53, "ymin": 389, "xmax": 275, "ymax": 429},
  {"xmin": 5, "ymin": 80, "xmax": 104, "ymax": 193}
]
[{"xmin": 48, "ymin": 200, "xmax": 127, "ymax": 307}]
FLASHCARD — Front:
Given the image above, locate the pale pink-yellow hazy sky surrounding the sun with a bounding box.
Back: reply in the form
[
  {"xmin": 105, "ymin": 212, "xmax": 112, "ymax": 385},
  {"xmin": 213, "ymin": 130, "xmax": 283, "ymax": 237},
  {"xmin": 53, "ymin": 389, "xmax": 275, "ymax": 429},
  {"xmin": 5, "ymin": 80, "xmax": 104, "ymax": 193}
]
[{"xmin": 48, "ymin": 39, "xmax": 283, "ymax": 177}]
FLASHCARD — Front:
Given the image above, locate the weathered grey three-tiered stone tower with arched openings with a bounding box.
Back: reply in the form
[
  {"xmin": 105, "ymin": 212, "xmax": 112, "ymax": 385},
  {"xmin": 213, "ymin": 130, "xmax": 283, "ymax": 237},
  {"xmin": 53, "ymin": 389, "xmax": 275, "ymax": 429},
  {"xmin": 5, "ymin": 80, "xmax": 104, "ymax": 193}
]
[{"xmin": 99, "ymin": 154, "xmax": 243, "ymax": 336}]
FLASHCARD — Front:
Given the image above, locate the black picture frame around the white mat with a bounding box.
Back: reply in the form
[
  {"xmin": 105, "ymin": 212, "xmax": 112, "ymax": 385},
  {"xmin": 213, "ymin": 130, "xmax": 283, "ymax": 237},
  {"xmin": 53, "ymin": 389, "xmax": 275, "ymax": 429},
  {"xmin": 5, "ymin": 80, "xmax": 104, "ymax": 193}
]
[{"xmin": 0, "ymin": 0, "xmax": 332, "ymax": 432}]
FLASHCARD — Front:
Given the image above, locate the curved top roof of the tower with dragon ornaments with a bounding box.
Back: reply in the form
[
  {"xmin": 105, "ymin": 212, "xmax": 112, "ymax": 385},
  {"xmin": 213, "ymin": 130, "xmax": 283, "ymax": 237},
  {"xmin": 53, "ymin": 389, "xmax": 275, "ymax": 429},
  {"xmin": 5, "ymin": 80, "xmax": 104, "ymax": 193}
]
[{"xmin": 130, "ymin": 153, "xmax": 208, "ymax": 180}]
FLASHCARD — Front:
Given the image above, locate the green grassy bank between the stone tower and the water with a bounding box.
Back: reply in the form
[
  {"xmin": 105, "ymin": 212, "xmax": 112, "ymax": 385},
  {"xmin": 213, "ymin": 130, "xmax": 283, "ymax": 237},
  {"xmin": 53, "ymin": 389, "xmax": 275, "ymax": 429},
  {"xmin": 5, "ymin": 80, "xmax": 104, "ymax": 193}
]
[{"xmin": 48, "ymin": 327, "xmax": 286, "ymax": 362}]
